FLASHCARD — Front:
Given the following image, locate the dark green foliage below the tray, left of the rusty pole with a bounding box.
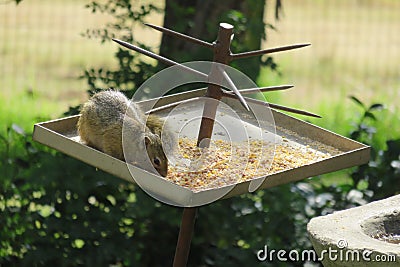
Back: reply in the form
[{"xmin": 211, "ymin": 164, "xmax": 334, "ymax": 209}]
[{"xmin": 0, "ymin": 125, "xmax": 179, "ymax": 266}]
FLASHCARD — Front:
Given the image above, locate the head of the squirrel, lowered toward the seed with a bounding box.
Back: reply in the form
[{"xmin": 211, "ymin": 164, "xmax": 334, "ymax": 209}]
[{"xmin": 144, "ymin": 133, "xmax": 168, "ymax": 177}]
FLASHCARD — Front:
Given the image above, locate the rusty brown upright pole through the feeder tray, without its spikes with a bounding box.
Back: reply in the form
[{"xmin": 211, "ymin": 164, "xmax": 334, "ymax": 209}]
[{"xmin": 173, "ymin": 23, "xmax": 233, "ymax": 267}]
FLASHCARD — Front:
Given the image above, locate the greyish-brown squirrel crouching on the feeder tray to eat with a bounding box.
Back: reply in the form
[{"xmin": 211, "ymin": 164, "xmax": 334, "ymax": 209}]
[{"xmin": 77, "ymin": 90, "xmax": 168, "ymax": 177}]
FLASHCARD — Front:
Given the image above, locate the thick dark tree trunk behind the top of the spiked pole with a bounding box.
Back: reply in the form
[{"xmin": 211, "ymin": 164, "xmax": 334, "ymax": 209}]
[{"xmin": 160, "ymin": 0, "xmax": 265, "ymax": 80}]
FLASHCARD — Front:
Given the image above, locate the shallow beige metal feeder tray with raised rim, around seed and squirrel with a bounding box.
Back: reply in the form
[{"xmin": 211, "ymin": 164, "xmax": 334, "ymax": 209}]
[{"xmin": 33, "ymin": 89, "xmax": 370, "ymax": 207}]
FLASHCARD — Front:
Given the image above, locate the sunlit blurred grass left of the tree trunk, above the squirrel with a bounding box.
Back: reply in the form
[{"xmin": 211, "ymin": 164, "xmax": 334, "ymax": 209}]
[{"xmin": 0, "ymin": 0, "xmax": 162, "ymax": 132}]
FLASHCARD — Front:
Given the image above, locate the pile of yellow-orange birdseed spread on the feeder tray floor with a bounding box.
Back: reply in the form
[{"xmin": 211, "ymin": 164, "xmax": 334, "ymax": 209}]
[{"xmin": 165, "ymin": 138, "xmax": 336, "ymax": 191}]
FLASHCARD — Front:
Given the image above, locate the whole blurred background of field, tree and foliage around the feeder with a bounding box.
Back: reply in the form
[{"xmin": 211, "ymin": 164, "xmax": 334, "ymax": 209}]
[{"xmin": 0, "ymin": 0, "xmax": 400, "ymax": 266}]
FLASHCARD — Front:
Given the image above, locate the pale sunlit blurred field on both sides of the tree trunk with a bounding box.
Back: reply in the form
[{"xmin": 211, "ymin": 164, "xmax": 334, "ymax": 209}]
[{"xmin": 0, "ymin": 0, "xmax": 400, "ymax": 136}]
